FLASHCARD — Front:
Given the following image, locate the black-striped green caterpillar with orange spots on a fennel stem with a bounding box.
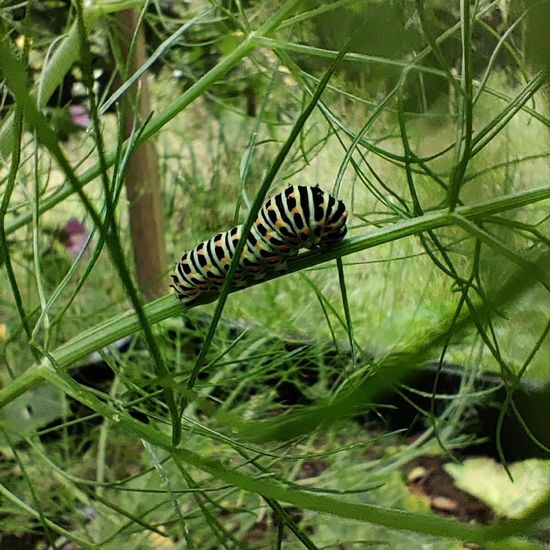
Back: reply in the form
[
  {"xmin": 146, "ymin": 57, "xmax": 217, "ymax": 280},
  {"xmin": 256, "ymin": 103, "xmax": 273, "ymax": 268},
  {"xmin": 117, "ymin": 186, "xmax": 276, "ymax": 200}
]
[{"xmin": 170, "ymin": 185, "xmax": 348, "ymax": 303}]
